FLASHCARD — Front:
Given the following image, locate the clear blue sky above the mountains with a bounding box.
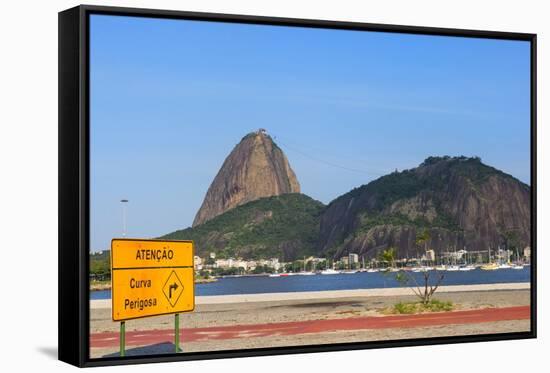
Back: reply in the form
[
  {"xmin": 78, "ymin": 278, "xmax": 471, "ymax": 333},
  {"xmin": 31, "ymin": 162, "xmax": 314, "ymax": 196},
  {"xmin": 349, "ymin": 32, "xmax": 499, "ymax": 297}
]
[{"xmin": 90, "ymin": 15, "xmax": 530, "ymax": 251}]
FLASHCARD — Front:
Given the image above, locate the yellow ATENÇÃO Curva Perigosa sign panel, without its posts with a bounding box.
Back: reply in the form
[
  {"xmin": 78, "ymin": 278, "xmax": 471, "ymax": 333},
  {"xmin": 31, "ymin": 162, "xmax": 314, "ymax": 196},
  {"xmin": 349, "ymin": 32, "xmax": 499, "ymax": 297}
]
[{"xmin": 111, "ymin": 239, "xmax": 195, "ymax": 321}]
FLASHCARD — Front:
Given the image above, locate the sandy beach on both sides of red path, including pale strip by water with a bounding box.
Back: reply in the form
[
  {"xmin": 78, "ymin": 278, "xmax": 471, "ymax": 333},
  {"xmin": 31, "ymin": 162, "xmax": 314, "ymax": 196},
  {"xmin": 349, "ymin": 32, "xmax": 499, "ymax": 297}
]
[{"xmin": 90, "ymin": 283, "xmax": 530, "ymax": 357}]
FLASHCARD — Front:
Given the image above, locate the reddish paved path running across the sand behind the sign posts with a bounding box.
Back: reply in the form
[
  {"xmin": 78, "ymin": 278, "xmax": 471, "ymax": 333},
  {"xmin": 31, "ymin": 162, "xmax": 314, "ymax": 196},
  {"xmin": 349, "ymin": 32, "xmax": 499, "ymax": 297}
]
[{"xmin": 90, "ymin": 306, "xmax": 531, "ymax": 348}]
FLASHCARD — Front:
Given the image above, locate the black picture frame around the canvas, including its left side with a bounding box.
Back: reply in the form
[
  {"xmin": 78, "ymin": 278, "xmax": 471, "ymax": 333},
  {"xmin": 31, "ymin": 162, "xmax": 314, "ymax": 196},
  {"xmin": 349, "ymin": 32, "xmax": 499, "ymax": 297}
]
[{"xmin": 58, "ymin": 5, "xmax": 537, "ymax": 367}]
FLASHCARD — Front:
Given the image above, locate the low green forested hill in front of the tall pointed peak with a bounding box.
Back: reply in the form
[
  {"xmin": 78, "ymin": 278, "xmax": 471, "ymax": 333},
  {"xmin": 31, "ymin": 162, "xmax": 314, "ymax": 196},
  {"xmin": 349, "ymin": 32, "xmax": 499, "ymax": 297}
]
[{"xmin": 161, "ymin": 193, "xmax": 324, "ymax": 261}]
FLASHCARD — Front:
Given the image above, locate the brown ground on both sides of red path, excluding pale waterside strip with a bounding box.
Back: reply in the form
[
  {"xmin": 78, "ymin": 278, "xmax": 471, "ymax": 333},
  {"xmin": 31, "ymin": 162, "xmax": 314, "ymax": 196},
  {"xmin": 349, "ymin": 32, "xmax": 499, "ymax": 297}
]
[{"xmin": 90, "ymin": 290, "xmax": 530, "ymax": 357}]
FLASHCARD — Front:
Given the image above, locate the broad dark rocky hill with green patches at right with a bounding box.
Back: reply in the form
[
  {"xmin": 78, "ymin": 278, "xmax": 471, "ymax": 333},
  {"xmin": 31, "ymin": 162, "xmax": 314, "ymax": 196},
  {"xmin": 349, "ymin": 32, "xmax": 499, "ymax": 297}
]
[{"xmin": 319, "ymin": 156, "xmax": 530, "ymax": 257}]
